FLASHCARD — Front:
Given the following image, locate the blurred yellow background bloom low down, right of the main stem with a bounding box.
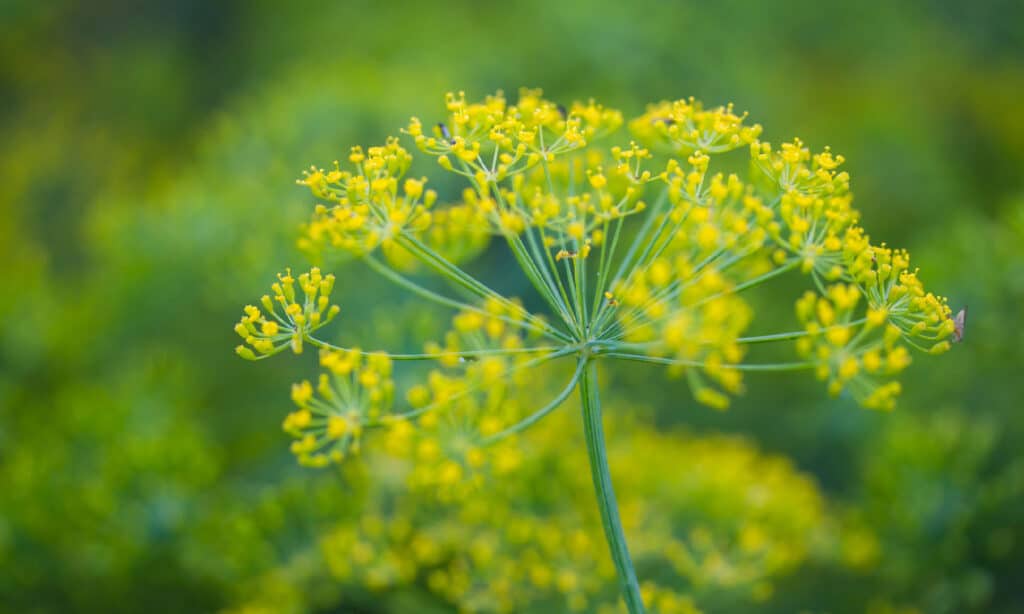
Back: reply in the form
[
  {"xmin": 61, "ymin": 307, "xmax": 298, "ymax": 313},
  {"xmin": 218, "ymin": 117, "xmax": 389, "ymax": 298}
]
[{"xmin": 609, "ymin": 417, "xmax": 825, "ymax": 590}]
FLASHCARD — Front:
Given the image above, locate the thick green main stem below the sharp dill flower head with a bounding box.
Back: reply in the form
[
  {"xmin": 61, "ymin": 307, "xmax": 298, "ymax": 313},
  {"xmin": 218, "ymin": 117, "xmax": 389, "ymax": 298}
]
[{"xmin": 580, "ymin": 359, "xmax": 644, "ymax": 614}]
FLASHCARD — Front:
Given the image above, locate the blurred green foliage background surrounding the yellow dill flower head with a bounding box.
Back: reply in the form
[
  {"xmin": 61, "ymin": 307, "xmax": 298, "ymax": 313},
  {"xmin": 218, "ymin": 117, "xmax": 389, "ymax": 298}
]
[{"xmin": 0, "ymin": 0, "xmax": 1024, "ymax": 613}]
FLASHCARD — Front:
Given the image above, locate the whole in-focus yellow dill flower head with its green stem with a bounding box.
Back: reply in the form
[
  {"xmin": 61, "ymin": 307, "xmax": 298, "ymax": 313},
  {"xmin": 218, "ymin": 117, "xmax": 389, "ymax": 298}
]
[{"xmin": 236, "ymin": 89, "xmax": 962, "ymax": 612}]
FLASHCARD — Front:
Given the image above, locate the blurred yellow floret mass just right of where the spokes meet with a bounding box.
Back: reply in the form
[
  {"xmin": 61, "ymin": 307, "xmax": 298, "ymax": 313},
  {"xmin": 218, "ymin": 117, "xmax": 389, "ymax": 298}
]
[{"xmin": 609, "ymin": 158, "xmax": 784, "ymax": 409}]
